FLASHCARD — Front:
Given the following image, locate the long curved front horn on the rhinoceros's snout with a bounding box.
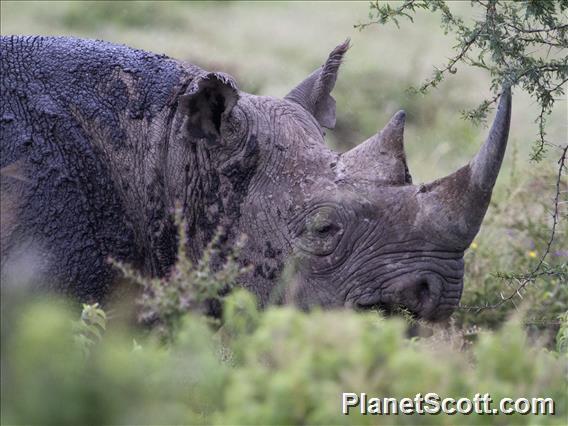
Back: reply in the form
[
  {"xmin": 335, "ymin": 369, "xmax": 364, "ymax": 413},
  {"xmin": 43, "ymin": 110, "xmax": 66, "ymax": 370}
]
[{"xmin": 417, "ymin": 88, "xmax": 511, "ymax": 248}]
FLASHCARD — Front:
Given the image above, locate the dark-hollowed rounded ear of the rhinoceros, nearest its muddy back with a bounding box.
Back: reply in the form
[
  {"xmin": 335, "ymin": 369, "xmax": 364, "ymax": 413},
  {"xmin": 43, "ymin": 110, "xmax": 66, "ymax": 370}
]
[{"xmin": 178, "ymin": 73, "xmax": 239, "ymax": 142}]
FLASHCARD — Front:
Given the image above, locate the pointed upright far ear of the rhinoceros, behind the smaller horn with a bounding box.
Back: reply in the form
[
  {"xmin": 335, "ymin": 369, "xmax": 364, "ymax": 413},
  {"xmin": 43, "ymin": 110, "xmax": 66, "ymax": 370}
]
[{"xmin": 284, "ymin": 39, "xmax": 349, "ymax": 129}]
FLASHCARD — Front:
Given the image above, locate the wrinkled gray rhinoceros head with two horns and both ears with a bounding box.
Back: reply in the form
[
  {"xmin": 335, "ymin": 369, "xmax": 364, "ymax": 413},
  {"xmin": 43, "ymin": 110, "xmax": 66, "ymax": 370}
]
[{"xmin": 181, "ymin": 42, "xmax": 511, "ymax": 320}]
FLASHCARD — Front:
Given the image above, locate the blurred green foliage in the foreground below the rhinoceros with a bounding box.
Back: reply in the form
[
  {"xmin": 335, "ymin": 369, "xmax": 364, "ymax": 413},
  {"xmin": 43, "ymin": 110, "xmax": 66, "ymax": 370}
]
[{"xmin": 1, "ymin": 290, "xmax": 568, "ymax": 424}]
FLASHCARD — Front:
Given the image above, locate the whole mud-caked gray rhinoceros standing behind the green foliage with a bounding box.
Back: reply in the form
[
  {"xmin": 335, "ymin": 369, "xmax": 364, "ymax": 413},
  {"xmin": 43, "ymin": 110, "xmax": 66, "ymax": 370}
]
[{"xmin": 0, "ymin": 37, "xmax": 511, "ymax": 320}]
